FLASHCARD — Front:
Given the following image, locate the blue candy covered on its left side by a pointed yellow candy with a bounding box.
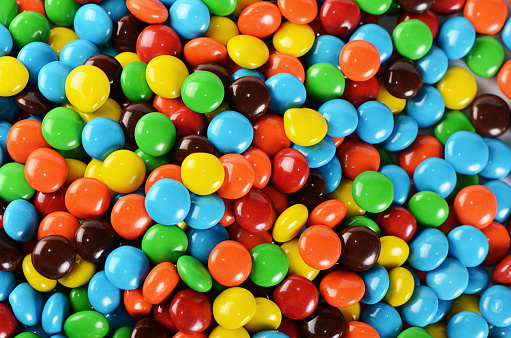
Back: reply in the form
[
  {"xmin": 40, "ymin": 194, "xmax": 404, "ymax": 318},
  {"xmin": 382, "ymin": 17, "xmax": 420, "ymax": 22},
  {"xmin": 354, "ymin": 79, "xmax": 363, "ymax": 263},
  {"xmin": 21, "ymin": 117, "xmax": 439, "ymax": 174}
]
[{"xmin": 318, "ymin": 99, "xmax": 358, "ymax": 137}]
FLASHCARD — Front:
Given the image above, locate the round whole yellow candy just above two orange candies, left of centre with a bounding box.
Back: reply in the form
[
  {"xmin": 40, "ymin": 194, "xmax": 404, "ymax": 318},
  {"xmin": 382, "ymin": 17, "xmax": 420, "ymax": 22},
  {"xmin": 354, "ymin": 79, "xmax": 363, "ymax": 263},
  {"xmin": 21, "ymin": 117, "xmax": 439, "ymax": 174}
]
[{"xmin": 101, "ymin": 149, "xmax": 146, "ymax": 194}]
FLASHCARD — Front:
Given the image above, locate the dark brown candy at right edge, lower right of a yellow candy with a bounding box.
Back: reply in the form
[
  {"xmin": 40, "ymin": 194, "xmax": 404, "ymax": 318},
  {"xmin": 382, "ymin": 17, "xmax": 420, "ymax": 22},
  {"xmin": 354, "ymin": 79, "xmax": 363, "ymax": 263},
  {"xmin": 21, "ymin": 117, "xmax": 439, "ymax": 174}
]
[{"xmin": 470, "ymin": 94, "xmax": 510, "ymax": 137}]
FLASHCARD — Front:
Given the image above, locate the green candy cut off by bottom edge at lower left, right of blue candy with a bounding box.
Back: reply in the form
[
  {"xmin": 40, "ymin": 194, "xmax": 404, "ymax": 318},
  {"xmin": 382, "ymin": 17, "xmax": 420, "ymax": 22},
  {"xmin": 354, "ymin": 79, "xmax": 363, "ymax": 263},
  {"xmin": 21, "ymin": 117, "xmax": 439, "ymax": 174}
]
[{"xmin": 64, "ymin": 311, "xmax": 110, "ymax": 338}]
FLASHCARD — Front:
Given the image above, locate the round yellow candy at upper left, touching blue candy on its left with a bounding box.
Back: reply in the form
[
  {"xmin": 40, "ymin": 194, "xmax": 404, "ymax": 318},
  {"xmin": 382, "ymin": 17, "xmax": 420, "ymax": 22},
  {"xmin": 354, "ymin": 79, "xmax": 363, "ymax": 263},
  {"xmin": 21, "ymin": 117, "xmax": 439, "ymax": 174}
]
[{"xmin": 66, "ymin": 66, "xmax": 110, "ymax": 113}]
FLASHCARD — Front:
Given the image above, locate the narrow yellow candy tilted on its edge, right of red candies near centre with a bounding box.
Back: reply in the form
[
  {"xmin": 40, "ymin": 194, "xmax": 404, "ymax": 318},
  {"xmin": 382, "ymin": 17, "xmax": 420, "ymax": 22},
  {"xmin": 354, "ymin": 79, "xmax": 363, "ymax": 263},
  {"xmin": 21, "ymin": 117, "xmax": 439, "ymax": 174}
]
[{"xmin": 272, "ymin": 204, "xmax": 309, "ymax": 243}]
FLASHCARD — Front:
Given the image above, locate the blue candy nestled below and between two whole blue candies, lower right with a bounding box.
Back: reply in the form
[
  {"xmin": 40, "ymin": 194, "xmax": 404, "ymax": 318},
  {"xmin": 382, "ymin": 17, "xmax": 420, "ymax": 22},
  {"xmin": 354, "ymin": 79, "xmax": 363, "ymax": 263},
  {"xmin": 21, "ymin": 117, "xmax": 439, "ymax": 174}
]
[{"xmin": 426, "ymin": 257, "xmax": 470, "ymax": 302}]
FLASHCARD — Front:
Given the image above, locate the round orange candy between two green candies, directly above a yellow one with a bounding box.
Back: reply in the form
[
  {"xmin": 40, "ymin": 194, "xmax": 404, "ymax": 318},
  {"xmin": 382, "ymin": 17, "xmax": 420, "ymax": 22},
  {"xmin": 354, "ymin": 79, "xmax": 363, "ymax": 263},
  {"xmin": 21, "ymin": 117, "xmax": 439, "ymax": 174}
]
[{"xmin": 208, "ymin": 241, "xmax": 252, "ymax": 287}]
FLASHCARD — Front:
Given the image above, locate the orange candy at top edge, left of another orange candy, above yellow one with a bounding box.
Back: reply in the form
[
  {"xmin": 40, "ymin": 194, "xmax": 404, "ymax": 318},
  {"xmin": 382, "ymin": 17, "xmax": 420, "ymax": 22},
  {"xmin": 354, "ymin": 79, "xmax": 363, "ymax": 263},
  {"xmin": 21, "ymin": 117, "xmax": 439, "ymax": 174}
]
[{"xmin": 238, "ymin": 1, "xmax": 282, "ymax": 39}]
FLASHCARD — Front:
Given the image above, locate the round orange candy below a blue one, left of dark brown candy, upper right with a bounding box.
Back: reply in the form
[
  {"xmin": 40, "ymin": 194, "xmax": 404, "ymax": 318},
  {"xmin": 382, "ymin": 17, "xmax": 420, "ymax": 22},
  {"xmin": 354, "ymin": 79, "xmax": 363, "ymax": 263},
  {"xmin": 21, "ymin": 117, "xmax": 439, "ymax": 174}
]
[{"xmin": 339, "ymin": 40, "xmax": 380, "ymax": 81}]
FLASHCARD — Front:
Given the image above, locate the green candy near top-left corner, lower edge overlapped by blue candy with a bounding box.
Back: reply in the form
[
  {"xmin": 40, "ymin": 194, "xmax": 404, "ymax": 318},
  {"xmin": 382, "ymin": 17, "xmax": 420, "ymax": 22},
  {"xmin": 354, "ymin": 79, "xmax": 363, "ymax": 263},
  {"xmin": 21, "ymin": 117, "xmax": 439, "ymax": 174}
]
[{"xmin": 9, "ymin": 11, "xmax": 50, "ymax": 49}]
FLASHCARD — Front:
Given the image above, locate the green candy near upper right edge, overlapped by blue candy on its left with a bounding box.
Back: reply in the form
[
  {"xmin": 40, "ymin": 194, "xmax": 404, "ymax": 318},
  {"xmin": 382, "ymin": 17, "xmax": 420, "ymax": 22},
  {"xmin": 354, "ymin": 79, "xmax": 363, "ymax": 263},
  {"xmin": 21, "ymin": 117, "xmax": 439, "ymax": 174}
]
[{"xmin": 465, "ymin": 35, "xmax": 505, "ymax": 77}]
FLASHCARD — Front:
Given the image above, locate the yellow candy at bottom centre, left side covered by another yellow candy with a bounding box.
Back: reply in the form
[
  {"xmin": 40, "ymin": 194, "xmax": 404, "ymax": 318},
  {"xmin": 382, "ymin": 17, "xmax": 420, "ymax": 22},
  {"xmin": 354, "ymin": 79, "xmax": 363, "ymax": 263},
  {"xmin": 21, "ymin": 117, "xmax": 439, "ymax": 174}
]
[{"xmin": 245, "ymin": 297, "xmax": 282, "ymax": 333}]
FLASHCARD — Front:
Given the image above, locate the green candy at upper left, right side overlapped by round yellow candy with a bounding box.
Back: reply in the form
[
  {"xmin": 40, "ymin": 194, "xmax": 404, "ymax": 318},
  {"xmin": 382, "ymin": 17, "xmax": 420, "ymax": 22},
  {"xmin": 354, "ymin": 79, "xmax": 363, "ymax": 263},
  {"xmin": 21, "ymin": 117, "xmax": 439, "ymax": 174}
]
[{"xmin": 121, "ymin": 61, "xmax": 154, "ymax": 102}]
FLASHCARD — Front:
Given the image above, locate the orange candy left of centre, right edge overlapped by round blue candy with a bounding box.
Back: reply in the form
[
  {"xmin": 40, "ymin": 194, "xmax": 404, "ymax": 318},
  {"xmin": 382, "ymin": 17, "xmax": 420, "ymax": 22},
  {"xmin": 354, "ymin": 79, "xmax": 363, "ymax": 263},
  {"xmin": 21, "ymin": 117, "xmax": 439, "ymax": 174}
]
[{"xmin": 110, "ymin": 194, "xmax": 153, "ymax": 239}]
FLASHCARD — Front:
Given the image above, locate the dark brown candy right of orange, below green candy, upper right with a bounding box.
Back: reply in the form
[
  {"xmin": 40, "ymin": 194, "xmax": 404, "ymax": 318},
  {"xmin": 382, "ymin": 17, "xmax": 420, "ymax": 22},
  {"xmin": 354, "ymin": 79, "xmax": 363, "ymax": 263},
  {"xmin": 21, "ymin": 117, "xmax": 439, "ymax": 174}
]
[{"xmin": 383, "ymin": 58, "xmax": 422, "ymax": 99}]
